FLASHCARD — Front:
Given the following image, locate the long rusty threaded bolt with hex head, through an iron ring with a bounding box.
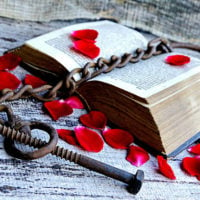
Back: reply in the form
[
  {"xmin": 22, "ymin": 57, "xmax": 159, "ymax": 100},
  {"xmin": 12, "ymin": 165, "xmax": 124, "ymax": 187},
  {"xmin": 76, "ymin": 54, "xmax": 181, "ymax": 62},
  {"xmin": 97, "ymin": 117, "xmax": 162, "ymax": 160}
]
[{"xmin": 0, "ymin": 124, "xmax": 144, "ymax": 194}]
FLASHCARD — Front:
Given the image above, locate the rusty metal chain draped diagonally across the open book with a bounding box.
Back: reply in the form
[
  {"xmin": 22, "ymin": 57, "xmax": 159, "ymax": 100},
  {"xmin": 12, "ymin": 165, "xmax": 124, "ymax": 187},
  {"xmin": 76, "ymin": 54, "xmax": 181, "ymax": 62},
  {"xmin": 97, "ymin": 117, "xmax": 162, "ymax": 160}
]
[{"xmin": 0, "ymin": 38, "xmax": 172, "ymax": 102}]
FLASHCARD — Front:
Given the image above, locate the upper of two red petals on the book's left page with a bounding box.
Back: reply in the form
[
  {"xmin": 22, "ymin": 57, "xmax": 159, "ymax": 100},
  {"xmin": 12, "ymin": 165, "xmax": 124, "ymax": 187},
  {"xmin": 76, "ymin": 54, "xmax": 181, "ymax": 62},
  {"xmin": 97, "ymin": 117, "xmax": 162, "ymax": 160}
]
[{"xmin": 71, "ymin": 29, "xmax": 98, "ymax": 40}]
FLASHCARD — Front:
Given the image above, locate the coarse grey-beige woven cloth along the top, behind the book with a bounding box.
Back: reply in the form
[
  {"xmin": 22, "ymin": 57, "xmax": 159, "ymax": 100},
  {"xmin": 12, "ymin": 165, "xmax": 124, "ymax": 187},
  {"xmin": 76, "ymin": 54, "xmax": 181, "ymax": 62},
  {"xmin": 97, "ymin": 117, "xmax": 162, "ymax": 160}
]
[{"xmin": 0, "ymin": 0, "xmax": 200, "ymax": 44}]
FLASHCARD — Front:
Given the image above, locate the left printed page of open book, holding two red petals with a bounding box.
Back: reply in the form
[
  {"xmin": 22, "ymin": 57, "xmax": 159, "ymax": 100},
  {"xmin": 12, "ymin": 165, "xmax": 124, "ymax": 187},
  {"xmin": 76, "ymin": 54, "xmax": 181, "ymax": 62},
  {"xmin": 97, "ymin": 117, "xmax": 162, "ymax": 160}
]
[{"xmin": 26, "ymin": 20, "xmax": 147, "ymax": 71}]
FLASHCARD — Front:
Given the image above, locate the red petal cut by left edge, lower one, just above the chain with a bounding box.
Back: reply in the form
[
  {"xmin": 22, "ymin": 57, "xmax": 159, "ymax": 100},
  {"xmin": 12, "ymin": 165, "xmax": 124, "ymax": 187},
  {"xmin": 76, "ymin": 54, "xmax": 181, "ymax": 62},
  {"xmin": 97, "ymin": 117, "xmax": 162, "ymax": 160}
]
[{"xmin": 0, "ymin": 72, "xmax": 21, "ymax": 90}]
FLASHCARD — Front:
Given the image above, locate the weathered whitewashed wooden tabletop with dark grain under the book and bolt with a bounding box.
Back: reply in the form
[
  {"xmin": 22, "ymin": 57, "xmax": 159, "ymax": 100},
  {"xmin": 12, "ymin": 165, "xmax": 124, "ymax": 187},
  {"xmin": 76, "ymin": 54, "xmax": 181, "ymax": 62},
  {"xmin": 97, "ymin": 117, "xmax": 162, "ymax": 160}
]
[{"xmin": 0, "ymin": 18, "xmax": 200, "ymax": 200}]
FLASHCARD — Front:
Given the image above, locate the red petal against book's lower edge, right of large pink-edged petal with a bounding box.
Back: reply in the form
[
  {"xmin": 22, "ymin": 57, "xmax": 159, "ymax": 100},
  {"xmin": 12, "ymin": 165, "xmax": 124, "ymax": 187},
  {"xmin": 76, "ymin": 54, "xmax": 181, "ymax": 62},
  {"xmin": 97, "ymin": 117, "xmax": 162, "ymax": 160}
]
[{"xmin": 103, "ymin": 129, "xmax": 133, "ymax": 149}]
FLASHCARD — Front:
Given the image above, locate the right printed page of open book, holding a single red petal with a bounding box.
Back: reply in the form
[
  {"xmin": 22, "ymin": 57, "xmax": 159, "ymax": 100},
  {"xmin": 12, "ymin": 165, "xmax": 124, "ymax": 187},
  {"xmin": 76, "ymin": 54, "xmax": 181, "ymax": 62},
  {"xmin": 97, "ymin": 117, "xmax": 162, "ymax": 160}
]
[{"xmin": 92, "ymin": 52, "xmax": 200, "ymax": 98}]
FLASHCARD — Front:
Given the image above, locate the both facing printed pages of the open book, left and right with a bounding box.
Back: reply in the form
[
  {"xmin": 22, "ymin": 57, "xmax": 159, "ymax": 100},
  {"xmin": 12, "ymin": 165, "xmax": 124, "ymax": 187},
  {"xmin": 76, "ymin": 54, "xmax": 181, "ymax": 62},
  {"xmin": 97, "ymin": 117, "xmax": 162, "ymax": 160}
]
[{"xmin": 26, "ymin": 20, "xmax": 200, "ymax": 98}]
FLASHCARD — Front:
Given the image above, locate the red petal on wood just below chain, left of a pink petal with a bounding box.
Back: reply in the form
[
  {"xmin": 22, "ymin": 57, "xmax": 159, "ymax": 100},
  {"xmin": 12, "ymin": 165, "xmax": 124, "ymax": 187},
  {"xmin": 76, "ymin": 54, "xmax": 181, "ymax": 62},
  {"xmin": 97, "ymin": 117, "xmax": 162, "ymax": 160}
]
[{"xmin": 44, "ymin": 100, "xmax": 73, "ymax": 120}]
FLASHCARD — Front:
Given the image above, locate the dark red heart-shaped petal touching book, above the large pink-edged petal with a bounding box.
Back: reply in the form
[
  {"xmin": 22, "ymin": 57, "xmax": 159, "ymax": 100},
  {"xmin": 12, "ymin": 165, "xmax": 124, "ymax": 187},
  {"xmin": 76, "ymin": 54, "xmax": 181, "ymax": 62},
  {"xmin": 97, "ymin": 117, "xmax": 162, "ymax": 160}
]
[{"xmin": 80, "ymin": 111, "xmax": 107, "ymax": 129}]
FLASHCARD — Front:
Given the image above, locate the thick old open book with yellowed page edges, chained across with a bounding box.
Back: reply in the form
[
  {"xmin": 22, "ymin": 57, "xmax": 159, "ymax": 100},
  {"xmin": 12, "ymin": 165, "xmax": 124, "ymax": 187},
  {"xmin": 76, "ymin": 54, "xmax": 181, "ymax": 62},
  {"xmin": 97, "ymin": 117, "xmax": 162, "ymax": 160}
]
[{"xmin": 11, "ymin": 21, "xmax": 200, "ymax": 155}]
